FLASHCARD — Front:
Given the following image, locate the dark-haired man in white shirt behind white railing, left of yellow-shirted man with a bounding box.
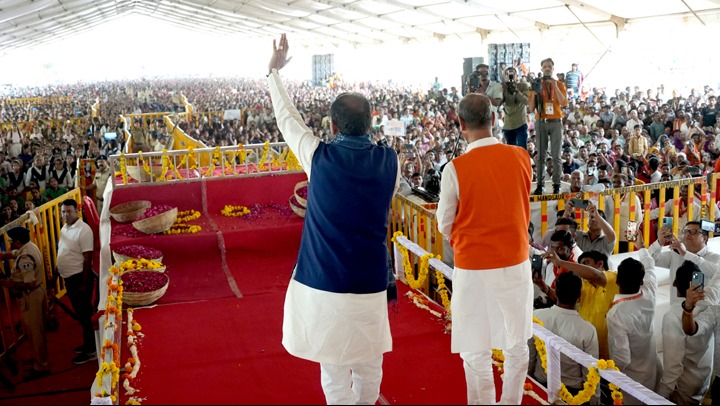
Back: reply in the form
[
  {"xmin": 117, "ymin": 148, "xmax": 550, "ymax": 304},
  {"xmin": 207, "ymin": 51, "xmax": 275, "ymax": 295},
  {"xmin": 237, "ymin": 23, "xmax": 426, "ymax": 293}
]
[{"xmin": 528, "ymin": 272, "xmax": 599, "ymax": 395}]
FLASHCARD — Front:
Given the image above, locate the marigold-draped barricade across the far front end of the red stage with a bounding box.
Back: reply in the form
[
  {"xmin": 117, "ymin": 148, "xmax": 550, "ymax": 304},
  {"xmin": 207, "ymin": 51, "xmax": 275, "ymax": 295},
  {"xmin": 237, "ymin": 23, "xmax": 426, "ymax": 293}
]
[{"xmin": 109, "ymin": 142, "xmax": 302, "ymax": 187}]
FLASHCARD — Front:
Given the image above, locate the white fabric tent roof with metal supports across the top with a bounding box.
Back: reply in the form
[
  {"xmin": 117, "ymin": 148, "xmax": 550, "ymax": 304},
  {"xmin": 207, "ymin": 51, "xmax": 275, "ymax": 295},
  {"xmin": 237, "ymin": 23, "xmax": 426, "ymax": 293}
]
[{"xmin": 0, "ymin": 0, "xmax": 720, "ymax": 52}]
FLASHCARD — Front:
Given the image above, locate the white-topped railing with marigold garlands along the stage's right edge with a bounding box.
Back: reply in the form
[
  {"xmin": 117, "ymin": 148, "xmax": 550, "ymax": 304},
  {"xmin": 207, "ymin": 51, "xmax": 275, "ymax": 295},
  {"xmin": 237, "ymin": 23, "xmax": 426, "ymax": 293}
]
[{"xmin": 393, "ymin": 236, "xmax": 674, "ymax": 405}]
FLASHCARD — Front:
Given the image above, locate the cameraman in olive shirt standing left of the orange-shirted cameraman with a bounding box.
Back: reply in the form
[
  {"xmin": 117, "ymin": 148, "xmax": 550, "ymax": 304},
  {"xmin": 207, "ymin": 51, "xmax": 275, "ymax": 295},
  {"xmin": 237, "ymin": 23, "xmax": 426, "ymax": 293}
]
[{"xmin": 502, "ymin": 67, "xmax": 529, "ymax": 150}]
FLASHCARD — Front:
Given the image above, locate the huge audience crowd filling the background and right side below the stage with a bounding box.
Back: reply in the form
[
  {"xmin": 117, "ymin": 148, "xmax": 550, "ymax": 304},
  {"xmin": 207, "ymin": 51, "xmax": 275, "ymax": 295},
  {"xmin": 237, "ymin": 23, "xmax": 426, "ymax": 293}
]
[{"xmin": 0, "ymin": 65, "xmax": 720, "ymax": 402}]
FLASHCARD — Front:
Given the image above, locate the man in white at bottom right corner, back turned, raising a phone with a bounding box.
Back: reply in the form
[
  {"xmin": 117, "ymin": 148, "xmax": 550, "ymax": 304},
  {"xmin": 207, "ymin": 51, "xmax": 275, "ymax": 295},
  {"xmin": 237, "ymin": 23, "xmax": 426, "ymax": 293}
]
[{"xmin": 657, "ymin": 261, "xmax": 717, "ymax": 405}]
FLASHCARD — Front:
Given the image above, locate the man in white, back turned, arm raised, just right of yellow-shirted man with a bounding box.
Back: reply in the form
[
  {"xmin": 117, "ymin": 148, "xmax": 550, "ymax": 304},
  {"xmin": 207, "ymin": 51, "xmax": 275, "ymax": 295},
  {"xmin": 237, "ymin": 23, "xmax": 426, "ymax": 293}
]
[{"xmin": 607, "ymin": 233, "xmax": 662, "ymax": 404}]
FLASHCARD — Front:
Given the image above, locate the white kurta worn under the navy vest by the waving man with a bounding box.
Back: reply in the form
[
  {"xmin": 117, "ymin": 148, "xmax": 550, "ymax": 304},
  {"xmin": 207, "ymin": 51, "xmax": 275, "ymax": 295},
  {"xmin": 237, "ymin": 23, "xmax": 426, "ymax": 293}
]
[{"xmin": 268, "ymin": 73, "xmax": 400, "ymax": 365}]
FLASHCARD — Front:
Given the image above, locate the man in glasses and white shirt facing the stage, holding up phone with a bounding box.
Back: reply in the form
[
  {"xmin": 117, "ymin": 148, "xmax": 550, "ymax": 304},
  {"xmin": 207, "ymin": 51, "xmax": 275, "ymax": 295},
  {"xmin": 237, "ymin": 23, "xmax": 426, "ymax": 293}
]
[{"xmin": 648, "ymin": 221, "xmax": 720, "ymax": 303}]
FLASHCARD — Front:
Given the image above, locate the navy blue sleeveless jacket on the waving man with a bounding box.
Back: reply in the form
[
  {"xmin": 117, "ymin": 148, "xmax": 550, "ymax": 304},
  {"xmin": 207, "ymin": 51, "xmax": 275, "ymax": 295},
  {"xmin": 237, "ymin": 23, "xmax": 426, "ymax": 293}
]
[{"xmin": 294, "ymin": 135, "xmax": 398, "ymax": 294}]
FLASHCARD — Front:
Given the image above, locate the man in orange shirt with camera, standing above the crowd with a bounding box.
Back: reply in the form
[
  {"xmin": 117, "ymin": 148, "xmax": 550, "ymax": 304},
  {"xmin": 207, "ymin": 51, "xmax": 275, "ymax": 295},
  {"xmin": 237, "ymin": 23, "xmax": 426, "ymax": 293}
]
[{"xmin": 528, "ymin": 58, "xmax": 567, "ymax": 195}]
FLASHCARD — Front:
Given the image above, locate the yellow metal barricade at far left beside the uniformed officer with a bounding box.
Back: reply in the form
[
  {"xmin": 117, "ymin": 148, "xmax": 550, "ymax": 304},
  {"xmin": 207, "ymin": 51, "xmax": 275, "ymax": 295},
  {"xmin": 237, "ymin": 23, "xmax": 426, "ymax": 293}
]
[{"xmin": 0, "ymin": 188, "xmax": 82, "ymax": 357}]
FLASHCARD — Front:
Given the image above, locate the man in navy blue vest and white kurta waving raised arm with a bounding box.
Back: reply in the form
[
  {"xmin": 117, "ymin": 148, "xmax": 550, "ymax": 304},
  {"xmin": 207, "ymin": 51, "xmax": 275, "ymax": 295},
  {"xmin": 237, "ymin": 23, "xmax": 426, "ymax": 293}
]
[{"xmin": 268, "ymin": 34, "xmax": 400, "ymax": 404}]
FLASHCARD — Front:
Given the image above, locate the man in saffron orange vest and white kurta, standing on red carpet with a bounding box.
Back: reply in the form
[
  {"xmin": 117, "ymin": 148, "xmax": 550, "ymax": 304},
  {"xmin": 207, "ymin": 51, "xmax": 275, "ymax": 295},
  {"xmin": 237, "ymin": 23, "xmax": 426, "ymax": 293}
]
[{"xmin": 437, "ymin": 93, "xmax": 533, "ymax": 405}]
